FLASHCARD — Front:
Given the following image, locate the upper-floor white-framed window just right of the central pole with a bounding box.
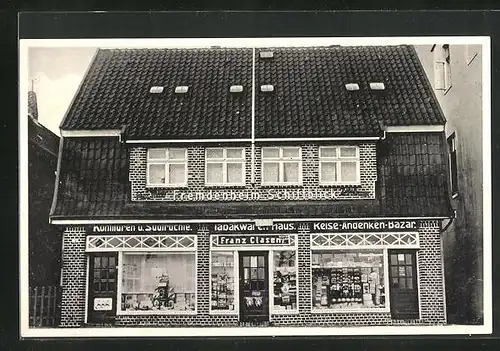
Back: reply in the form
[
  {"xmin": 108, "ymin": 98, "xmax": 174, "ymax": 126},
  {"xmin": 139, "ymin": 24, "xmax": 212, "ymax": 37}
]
[{"xmin": 262, "ymin": 147, "xmax": 302, "ymax": 185}]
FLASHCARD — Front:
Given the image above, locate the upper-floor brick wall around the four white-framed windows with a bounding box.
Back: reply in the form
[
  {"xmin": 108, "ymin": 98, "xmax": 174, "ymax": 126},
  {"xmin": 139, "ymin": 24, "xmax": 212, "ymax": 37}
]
[{"xmin": 129, "ymin": 143, "xmax": 377, "ymax": 201}]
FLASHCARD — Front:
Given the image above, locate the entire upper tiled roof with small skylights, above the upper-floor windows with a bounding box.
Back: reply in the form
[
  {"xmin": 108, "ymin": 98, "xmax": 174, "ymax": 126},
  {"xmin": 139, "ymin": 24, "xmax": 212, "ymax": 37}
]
[{"xmin": 61, "ymin": 45, "xmax": 445, "ymax": 140}]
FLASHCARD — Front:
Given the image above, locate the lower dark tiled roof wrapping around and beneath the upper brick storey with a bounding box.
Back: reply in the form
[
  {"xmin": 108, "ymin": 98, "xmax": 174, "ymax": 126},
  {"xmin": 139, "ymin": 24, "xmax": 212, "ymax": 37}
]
[{"xmin": 51, "ymin": 133, "xmax": 452, "ymax": 219}]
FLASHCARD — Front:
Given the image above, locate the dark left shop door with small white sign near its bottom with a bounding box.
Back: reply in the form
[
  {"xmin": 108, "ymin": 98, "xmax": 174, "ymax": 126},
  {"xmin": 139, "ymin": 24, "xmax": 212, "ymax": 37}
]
[{"xmin": 87, "ymin": 252, "xmax": 118, "ymax": 324}]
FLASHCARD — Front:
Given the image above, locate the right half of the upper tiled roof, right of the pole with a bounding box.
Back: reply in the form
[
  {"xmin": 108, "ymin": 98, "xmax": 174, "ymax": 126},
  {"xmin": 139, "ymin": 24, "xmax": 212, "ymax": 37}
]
[{"xmin": 255, "ymin": 45, "xmax": 445, "ymax": 138}]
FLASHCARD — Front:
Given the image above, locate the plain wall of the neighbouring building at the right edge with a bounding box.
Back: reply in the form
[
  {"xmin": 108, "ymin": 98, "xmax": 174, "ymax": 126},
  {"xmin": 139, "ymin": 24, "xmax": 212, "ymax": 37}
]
[{"xmin": 415, "ymin": 44, "xmax": 483, "ymax": 324}]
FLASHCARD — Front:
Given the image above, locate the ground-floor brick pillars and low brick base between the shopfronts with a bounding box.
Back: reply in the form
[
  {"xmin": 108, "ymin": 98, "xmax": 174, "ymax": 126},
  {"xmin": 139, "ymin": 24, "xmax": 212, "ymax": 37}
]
[{"xmin": 61, "ymin": 221, "xmax": 446, "ymax": 327}]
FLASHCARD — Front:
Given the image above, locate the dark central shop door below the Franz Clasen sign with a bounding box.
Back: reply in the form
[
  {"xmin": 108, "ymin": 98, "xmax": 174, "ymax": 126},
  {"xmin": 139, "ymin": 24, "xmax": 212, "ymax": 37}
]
[{"xmin": 239, "ymin": 251, "xmax": 269, "ymax": 322}]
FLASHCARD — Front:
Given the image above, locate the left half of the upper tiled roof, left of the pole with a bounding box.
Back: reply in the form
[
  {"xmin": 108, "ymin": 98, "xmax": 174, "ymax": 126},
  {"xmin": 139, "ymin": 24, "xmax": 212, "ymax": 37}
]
[{"xmin": 61, "ymin": 48, "xmax": 252, "ymax": 139}]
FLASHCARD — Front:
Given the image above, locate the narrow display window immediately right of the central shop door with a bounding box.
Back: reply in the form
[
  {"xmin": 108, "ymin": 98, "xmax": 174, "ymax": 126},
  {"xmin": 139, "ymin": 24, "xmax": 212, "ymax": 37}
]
[{"xmin": 272, "ymin": 251, "xmax": 298, "ymax": 312}]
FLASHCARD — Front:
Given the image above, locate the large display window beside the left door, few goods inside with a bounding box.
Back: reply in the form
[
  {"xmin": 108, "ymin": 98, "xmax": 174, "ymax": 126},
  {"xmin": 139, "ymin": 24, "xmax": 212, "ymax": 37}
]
[{"xmin": 119, "ymin": 252, "xmax": 196, "ymax": 313}]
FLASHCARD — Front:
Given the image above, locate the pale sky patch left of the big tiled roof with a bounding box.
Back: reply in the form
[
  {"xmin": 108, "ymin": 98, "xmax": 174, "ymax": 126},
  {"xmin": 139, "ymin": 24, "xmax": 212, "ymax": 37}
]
[{"xmin": 28, "ymin": 47, "xmax": 96, "ymax": 135}]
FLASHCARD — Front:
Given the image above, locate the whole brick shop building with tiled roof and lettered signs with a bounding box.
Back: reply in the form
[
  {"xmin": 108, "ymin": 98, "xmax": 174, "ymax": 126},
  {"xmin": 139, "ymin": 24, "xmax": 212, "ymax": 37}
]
[{"xmin": 50, "ymin": 46, "xmax": 453, "ymax": 327}]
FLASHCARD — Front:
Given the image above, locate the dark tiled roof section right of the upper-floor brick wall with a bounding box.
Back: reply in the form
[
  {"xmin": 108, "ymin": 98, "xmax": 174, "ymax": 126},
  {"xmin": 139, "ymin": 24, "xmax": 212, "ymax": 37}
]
[{"xmin": 378, "ymin": 133, "xmax": 453, "ymax": 216}]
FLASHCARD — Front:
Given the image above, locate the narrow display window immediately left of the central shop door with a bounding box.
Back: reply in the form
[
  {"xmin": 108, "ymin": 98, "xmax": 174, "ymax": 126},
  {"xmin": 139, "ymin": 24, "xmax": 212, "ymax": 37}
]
[{"xmin": 210, "ymin": 251, "xmax": 236, "ymax": 312}]
